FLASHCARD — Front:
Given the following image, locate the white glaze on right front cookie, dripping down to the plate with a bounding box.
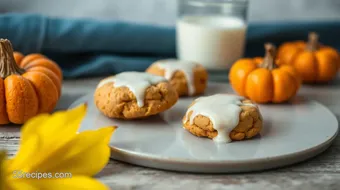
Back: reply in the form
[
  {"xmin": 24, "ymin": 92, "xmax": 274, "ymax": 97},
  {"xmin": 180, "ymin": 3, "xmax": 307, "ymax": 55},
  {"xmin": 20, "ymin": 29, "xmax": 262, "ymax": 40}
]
[{"xmin": 183, "ymin": 94, "xmax": 258, "ymax": 143}]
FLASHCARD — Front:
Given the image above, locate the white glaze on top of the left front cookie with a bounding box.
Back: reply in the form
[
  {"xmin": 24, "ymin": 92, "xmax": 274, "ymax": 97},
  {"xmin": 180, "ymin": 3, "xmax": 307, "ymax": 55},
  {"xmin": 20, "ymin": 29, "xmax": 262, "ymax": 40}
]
[{"xmin": 97, "ymin": 71, "xmax": 167, "ymax": 107}]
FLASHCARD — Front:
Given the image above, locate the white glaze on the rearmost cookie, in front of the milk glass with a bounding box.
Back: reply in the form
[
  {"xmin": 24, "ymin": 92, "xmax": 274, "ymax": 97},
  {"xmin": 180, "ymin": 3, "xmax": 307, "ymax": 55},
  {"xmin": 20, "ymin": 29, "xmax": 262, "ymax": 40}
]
[{"xmin": 156, "ymin": 59, "xmax": 197, "ymax": 96}]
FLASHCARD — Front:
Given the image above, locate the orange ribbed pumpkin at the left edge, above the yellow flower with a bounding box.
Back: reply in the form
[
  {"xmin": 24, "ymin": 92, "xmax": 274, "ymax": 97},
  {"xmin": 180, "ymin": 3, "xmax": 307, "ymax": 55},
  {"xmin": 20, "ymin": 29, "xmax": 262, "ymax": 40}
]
[{"xmin": 0, "ymin": 39, "xmax": 62, "ymax": 124}]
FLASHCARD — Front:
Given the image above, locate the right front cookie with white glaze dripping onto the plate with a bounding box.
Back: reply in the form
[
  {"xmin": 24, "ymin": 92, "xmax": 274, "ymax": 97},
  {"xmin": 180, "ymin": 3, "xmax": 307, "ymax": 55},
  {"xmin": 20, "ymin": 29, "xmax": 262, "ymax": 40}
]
[{"xmin": 183, "ymin": 94, "xmax": 263, "ymax": 143}]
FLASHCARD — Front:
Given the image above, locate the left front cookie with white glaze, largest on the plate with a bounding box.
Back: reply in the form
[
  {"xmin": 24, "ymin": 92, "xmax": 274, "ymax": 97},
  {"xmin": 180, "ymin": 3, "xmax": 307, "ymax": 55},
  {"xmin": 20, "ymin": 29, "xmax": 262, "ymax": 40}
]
[{"xmin": 94, "ymin": 72, "xmax": 178, "ymax": 119}]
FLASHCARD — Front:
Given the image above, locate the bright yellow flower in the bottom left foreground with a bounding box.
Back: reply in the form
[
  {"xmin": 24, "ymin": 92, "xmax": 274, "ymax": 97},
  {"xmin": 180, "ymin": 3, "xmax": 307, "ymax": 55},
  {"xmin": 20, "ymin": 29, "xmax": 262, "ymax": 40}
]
[{"xmin": 0, "ymin": 105, "xmax": 115, "ymax": 190}]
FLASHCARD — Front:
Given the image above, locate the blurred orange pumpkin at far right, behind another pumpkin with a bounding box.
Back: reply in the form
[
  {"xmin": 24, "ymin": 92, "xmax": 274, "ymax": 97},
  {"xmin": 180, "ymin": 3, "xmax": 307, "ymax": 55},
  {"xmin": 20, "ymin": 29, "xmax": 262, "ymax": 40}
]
[{"xmin": 277, "ymin": 32, "xmax": 340, "ymax": 83}]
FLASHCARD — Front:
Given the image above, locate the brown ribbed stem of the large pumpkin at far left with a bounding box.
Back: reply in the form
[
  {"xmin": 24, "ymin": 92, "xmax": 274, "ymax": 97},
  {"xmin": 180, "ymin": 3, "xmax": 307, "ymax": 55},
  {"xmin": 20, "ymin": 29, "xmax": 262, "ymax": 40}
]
[{"xmin": 0, "ymin": 39, "xmax": 25, "ymax": 79}]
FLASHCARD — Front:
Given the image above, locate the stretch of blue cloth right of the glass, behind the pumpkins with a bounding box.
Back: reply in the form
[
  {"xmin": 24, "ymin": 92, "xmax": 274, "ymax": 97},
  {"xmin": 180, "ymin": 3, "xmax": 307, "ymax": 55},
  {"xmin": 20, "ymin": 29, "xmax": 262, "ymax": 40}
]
[{"xmin": 245, "ymin": 21, "xmax": 340, "ymax": 57}]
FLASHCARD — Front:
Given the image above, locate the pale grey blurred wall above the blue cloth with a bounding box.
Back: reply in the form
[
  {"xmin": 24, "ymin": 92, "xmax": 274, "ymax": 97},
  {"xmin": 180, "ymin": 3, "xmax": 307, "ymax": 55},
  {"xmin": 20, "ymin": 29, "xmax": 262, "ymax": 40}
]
[{"xmin": 0, "ymin": 0, "xmax": 340, "ymax": 26}]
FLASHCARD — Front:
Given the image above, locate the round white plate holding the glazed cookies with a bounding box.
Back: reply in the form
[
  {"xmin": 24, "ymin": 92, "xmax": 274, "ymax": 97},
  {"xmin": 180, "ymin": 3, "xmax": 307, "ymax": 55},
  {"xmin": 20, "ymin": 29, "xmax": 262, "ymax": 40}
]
[{"xmin": 71, "ymin": 83, "xmax": 338, "ymax": 173}]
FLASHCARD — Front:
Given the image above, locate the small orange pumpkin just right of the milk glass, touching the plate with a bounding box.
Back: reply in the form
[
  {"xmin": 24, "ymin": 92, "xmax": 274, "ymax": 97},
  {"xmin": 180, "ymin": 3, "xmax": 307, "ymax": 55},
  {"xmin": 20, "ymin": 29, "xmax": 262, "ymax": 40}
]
[{"xmin": 229, "ymin": 43, "xmax": 301, "ymax": 103}]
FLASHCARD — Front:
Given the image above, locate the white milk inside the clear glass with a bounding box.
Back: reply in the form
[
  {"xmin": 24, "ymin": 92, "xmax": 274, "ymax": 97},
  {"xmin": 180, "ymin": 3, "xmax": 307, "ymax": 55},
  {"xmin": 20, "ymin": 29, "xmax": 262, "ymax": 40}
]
[{"xmin": 177, "ymin": 15, "xmax": 247, "ymax": 70}]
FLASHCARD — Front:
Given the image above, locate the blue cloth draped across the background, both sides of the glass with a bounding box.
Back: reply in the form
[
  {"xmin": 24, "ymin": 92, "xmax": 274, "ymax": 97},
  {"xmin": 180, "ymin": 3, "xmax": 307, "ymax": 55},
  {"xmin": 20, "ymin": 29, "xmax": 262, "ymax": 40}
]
[{"xmin": 0, "ymin": 13, "xmax": 340, "ymax": 78}]
